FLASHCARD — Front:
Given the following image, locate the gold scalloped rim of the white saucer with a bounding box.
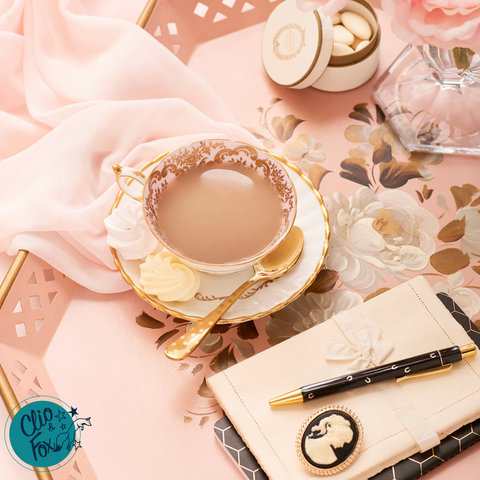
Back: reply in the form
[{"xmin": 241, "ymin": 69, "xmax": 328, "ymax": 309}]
[{"xmin": 110, "ymin": 147, "xmax": 330, "ymax": 324}]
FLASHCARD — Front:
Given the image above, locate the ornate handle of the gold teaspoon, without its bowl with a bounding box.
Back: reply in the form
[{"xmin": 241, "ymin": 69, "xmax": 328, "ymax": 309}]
[{"xmin": 165, "ymin": 274, "xmax": 262, "ymax": 360}]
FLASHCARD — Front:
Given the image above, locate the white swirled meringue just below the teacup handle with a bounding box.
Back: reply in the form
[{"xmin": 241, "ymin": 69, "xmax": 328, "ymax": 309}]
[{"xmin": 104, "ymin": 203, "xmax": 159, "ymax": 260}]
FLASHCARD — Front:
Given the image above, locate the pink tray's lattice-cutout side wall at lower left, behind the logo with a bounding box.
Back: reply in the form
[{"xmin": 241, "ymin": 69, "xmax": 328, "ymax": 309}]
[{"xmin": 0, "ymin": 253, "xmax": 97, "ymax": 480}]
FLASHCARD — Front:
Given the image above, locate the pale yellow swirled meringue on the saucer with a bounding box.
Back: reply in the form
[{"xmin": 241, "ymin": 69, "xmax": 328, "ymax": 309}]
[{"xmin": 138, "ymin": 250, "xmax": 200, "ymax": 302}]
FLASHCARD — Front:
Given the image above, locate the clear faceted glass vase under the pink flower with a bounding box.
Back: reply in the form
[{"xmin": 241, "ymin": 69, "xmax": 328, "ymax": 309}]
[{"xmin": 373, "ymin": 45, "xmax": 480, "ymax": 155}]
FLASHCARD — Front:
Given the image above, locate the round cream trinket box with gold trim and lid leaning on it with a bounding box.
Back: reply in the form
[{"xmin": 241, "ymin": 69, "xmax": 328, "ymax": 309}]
[{"xmin": 262, "ymin": 0, "xmax": 380, "ymax": 92}]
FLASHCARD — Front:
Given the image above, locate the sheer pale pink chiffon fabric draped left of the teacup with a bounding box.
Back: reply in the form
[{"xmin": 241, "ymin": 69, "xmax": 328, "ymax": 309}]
[{"xmin": 0, "ymin": 0, "xmax": 255, "ymax": 293}]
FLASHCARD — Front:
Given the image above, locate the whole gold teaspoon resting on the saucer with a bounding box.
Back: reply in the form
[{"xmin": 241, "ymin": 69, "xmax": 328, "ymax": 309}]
[{"xmin": 165, "ymin": 226, "xmax": 304, "ymax": 360}]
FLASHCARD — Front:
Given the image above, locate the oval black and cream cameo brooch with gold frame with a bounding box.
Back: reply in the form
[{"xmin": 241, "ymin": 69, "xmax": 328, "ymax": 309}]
[{"xmin": 295, "ymin": 405, "xmax": 363, "ymax": 475}]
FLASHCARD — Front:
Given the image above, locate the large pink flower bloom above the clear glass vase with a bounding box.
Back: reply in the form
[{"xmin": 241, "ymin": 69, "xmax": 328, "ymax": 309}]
[{"xmin": 382, "ymin": 0, "xmax": 480, "ymax": 52}]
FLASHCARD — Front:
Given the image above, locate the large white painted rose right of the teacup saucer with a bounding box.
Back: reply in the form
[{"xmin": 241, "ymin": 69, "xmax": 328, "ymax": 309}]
[{"xmin": 325, "ymin": 187, "xmax": 439, "ymax": 293}]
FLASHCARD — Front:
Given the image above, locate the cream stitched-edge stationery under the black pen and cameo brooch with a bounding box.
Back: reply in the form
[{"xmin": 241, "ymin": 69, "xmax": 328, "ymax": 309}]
[{"xmin": 208, "ymin": 277, "xmax": 480, "ymax": 480}]
